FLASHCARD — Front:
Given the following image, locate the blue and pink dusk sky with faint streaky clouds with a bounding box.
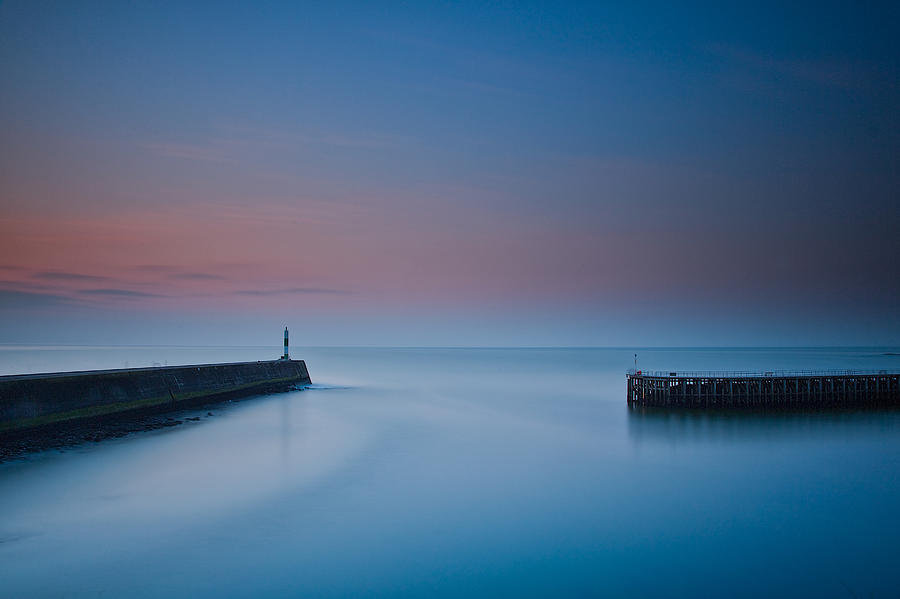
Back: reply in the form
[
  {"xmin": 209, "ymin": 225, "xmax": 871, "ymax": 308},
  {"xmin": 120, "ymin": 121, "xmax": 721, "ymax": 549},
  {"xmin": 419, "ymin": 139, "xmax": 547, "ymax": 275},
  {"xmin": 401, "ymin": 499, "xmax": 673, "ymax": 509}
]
[{"xmin": 0, "ymin": 0, "xmax": 900, "ymax": 347}]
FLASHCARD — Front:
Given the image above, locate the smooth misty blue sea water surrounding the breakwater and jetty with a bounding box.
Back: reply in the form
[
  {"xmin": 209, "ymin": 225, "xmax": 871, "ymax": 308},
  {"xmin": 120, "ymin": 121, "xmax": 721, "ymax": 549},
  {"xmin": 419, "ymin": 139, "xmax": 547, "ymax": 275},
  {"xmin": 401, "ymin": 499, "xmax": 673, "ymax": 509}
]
[{"xmin": 0, "ymin": 347, "xmax": 900, "ymax": 597}]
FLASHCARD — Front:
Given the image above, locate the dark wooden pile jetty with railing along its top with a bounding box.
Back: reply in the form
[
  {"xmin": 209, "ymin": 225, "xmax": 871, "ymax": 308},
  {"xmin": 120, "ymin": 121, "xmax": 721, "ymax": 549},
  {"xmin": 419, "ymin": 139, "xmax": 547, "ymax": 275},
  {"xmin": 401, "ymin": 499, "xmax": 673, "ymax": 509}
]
[{"xmin": 626, "ymin": 370, "xmax": 900, "ymax": 410}]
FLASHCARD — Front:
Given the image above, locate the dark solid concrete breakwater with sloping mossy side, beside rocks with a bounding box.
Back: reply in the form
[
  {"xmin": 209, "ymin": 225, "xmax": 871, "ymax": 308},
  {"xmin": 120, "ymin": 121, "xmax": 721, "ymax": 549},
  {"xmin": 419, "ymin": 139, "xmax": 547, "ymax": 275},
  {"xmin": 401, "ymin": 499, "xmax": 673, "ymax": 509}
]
[{"xmin": 0, "ymin": 359, "xmax": 310, "ymax": 433}]
